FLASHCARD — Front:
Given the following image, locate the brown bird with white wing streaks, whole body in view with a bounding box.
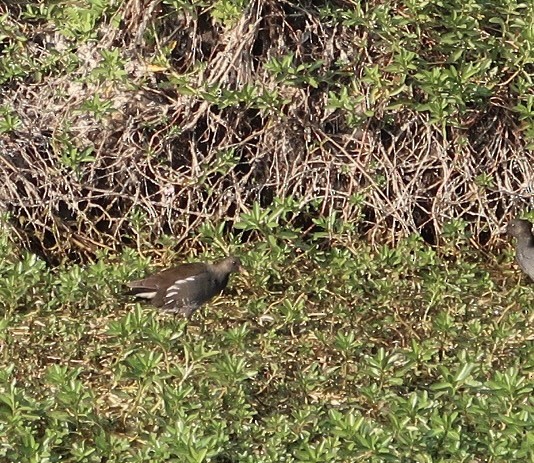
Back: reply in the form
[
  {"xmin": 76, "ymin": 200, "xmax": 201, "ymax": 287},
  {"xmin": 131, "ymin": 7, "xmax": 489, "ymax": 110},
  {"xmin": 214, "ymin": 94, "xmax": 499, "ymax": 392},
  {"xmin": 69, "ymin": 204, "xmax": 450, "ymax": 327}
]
[{"xmin": 126, "ymin": 256, "xmax": 245, "ymax": 319}]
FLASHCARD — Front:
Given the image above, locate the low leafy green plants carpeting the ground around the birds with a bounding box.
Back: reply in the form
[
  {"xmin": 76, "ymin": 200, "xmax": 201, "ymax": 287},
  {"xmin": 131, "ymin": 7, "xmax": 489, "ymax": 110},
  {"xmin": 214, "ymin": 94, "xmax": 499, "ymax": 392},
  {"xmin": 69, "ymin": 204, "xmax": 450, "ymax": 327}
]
[{"xmin": 0, "ymin": 208, "xmax": 534, "ymax": 463}]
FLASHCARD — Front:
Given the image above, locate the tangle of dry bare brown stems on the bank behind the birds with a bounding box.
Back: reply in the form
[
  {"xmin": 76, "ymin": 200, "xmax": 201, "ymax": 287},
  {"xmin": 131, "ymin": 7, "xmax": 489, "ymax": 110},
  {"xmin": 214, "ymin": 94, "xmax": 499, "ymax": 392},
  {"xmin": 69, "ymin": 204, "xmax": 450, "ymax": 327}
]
[{"xmin": 0, "ymin": 0, "xmax": 534, "ymax": 257}]
